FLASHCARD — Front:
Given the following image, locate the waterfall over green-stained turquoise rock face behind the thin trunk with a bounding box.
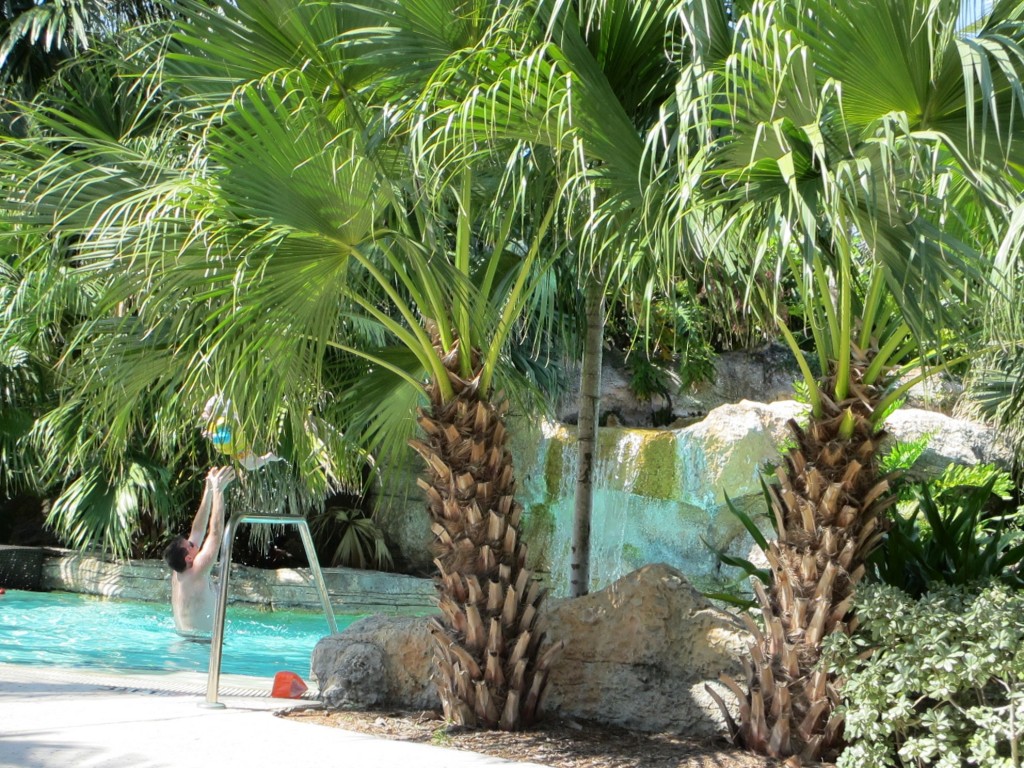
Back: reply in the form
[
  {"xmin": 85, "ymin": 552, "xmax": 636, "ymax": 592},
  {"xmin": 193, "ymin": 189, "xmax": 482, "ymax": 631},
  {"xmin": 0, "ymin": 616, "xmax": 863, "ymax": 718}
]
[{"xmin": 517, "ymin": 401, "xmax": 802, "ymax": 597}]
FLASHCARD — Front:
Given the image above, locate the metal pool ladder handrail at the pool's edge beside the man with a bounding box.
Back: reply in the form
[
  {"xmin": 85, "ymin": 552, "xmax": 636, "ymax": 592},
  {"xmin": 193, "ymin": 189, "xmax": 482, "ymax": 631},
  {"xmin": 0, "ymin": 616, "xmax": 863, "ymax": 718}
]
[{"xmin": 200, "ymin": 512, "xmax": 338, "ymax": 710}]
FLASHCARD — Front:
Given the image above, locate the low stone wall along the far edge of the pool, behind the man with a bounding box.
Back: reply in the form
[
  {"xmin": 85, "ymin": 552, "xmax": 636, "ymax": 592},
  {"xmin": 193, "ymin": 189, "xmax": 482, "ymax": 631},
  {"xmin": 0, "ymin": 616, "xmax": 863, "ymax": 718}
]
[{"xmin": 40, "ymin": 550, "xmax": 434, "ymax": 614}]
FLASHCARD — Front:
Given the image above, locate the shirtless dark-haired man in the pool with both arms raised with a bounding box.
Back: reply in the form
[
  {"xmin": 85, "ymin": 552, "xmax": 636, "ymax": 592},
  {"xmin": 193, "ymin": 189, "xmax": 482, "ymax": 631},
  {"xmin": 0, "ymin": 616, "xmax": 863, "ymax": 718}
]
[{"xmin": 164, "ymin": 467, "xmax": 234, "ymax": 637}]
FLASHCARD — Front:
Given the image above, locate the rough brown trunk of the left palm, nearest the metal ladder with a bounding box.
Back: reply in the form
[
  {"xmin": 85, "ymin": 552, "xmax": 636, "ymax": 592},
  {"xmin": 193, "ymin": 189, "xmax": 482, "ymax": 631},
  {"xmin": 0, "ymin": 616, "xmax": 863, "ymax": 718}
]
[{"xmin": 411, "ymin": 333, "xmax": 562, "ymax": 730}]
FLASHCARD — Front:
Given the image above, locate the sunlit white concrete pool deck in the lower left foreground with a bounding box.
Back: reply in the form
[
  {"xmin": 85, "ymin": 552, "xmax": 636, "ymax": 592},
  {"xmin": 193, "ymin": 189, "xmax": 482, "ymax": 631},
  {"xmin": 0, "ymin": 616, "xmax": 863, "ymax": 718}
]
[{"xmin": 0, "ymin": 664, "xmax": 538, "ymax": 768}]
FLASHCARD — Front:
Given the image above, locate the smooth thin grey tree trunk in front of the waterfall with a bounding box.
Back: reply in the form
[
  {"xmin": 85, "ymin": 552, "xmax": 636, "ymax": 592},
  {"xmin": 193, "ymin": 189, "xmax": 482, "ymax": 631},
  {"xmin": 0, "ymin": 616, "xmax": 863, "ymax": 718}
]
[{"xmin": 569, "ymin": 272, "xmax": 604, "ymax": 597}]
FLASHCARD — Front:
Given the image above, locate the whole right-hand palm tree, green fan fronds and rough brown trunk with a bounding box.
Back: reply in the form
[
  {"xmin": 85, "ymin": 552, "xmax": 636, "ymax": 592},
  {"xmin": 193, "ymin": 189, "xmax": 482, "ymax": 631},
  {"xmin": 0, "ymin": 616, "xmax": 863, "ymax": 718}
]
[{"xmin": 666, "ymin": 0, "xmax": 1024, "ymax": 760}]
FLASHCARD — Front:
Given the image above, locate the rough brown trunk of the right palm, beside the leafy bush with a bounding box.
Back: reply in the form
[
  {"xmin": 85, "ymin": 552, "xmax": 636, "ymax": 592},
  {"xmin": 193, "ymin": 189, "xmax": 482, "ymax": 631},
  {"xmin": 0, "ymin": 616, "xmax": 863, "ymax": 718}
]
[{"xmin": 713, "ymin": 360, "xmax": 895, "ymax": 762}]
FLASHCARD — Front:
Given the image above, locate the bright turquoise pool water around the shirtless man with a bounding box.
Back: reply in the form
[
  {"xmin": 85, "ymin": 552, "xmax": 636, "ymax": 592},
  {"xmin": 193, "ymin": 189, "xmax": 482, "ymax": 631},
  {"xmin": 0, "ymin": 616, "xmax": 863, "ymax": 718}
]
[{"xmin": 0, "ymin": 590, "xmax": 362, "ymax": 679}]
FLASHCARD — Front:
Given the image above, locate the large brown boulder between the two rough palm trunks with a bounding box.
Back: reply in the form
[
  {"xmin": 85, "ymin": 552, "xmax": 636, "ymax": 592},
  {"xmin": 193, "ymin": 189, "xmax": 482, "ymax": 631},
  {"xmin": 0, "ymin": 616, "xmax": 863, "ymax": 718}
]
[{"xmin": 544, "ymin": 564, "xmax": 746, "ymax": 736}]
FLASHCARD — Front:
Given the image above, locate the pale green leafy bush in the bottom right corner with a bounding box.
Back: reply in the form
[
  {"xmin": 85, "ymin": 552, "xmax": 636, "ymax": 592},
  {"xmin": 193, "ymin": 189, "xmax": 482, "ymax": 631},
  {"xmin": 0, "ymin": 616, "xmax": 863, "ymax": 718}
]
[{"xmin": 824, "ymin": 584, "xmax": 1024, "ymax": 768}]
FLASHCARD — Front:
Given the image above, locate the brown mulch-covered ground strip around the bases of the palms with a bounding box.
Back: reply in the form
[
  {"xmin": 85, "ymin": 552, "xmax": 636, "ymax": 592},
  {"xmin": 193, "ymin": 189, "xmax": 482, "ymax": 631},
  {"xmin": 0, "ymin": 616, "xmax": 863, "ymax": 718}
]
[{"xmin": 283, "ymin": 707, "xmax": 782, "ymax": 768}]
